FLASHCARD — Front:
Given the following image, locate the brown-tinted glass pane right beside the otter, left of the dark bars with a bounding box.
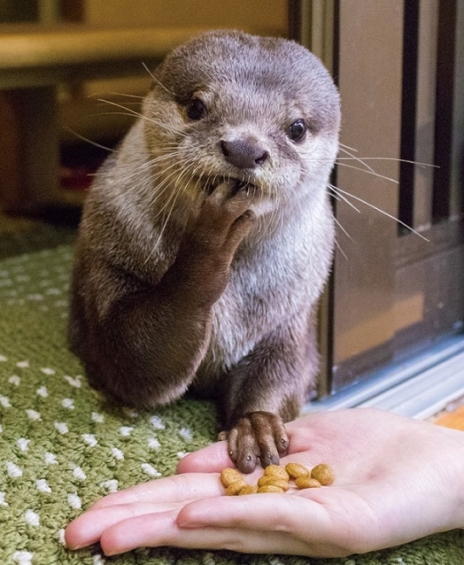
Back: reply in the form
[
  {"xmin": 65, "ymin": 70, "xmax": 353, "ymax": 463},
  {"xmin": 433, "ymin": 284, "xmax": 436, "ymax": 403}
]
[{"xmin": 332, "ymin": 0, "xmax": 403, "ymax": 391}]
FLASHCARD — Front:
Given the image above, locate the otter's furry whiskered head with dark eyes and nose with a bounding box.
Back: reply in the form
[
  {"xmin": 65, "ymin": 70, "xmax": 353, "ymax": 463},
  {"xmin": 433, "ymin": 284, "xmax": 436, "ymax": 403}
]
[{"xmin": 143, "ymin": 32, "xmax": 340, "ymax": 215}]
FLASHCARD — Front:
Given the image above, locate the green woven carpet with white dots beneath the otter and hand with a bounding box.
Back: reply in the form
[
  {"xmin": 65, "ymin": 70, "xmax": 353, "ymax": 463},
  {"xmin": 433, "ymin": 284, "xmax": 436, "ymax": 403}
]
[{"xmin": 0, "ymin": 221, "xmax": 464, "ymax": 565}]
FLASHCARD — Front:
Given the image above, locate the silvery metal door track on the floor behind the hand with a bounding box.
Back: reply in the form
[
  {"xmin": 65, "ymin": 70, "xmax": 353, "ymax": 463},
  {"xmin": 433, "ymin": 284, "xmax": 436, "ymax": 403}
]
[{"xmin": 303, "ymin": 335, "xmax": 464, "ymax": 419}]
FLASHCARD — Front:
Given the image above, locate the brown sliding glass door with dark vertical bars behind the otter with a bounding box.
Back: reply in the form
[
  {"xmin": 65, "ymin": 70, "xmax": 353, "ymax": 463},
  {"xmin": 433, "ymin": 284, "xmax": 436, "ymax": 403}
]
[{"xmin": 290, "ymin": 0, "xmax": 464, "ymax": 395}]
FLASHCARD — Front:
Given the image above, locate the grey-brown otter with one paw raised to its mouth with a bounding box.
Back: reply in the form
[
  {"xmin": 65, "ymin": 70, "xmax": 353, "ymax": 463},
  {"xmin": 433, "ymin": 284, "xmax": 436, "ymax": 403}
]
[{"xmin": 69, "ymin": 31, "xmax": 340, "ymax": 473}]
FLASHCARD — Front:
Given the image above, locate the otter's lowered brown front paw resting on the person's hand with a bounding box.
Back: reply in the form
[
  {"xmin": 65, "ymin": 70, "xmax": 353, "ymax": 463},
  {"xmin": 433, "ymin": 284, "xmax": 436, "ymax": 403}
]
[{"xmin": 223, "ymin": 412, "xmax": 289, "ymax": 473}]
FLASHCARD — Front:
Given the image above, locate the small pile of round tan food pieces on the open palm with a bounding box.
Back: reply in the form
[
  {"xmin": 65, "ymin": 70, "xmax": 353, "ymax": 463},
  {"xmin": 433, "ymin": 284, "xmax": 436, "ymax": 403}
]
[{"xmin": 221, "ymin": 463, "xmax": 335, "ymax": 496}]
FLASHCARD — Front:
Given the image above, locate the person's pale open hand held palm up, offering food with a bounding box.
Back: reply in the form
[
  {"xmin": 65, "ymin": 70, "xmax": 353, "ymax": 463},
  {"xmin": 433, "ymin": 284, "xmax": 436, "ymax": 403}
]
[{"xmin": 66, "ymin": 409, "xmax": 464, "ymax": 557}]
